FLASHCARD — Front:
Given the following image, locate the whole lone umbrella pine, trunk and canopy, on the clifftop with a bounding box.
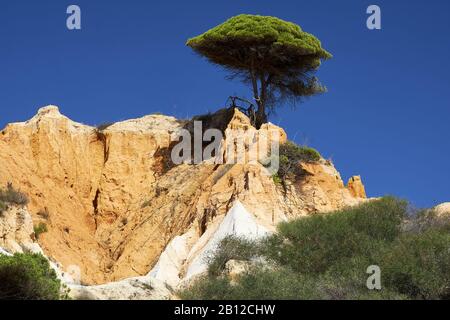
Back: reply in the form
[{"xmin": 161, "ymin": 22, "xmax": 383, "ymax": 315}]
[{"xmin": 186, "ymin": 14, "xmax": 331, "ymax": 127}]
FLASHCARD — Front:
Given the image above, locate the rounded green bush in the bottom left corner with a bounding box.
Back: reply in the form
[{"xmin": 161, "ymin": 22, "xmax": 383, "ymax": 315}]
[{"xmin": 0, "ymin": 253, "xmax": 63, "ymax": 300}]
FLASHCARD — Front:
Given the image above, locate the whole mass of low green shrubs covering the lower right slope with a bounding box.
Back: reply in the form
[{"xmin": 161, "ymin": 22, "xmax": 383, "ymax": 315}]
[{"xmin": 179, "ymin": 197, "xmax": 450, "ymax": 300}]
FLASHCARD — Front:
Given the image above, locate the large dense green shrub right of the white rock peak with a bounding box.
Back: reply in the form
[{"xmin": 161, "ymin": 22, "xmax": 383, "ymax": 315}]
[{"xmin": 265, "ymin": 198, "xmax": 406, "ymax": 273}]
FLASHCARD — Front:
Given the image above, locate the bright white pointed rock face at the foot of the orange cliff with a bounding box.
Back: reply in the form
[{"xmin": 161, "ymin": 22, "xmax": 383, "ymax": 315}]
[{"xmin": 185, "ymin": 201, "xmax": 269, "ymax": 280}]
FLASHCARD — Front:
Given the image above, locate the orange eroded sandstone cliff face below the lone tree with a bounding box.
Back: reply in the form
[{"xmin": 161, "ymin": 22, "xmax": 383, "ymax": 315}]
[{"xmin": 0, "ymin": 106, "xmax": 365, "ymax": 284}]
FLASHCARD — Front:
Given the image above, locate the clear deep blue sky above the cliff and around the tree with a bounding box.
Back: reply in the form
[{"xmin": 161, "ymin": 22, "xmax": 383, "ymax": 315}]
[{"xmin": 0, "ymin": 0, "xmax": 450, "ymax": 207}]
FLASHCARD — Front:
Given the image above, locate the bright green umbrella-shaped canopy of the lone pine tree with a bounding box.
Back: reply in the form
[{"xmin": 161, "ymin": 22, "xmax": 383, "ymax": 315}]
[{"xmin": 187, "ymin": 14, "xmax": 331, "ymax": 69}]
